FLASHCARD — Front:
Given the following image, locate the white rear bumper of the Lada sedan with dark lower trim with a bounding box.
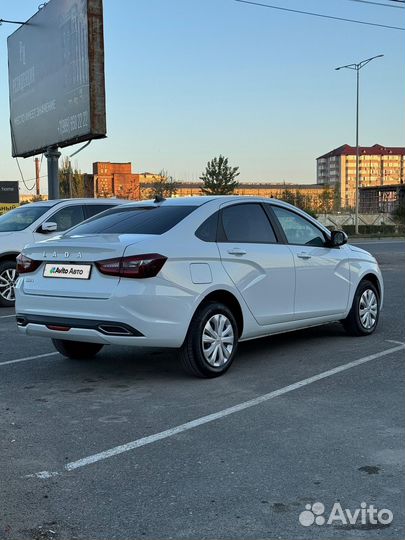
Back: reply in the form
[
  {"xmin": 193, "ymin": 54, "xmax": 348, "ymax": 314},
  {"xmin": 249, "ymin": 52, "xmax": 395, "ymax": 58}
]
[{"xmin": 16, "ymin": 280, "xmax": 196, "ymax": 348}]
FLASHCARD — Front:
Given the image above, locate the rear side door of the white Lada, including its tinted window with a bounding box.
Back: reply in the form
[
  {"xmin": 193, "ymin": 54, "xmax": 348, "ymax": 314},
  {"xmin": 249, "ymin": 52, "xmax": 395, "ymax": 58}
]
[{"xmin": 218, "ymin": 202, "xmax": 295, "ymax": 326}]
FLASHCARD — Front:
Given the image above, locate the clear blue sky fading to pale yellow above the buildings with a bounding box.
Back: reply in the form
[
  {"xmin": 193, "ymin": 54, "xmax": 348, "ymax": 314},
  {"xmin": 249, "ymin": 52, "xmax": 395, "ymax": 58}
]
[{"xmin": 0, "ymin": 0, "xmax": 405, "ymax": 194}]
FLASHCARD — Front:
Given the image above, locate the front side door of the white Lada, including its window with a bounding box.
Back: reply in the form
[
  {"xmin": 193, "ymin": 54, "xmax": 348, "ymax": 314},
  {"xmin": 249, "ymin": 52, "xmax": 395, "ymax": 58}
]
[{"xmin": 271, "ymin": 204, "xmax": 350, "ymax": 319}]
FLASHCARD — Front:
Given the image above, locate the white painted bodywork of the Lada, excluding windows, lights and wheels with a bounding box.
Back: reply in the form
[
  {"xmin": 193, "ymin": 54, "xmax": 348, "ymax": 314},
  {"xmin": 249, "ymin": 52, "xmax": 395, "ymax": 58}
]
[{"xmin": 16, "ymin": 196, "xmax": 383, "ymax": 348}]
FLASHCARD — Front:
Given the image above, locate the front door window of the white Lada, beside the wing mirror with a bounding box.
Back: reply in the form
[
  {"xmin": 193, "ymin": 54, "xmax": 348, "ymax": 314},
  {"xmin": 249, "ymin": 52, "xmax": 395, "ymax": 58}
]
[{"xmin": 272, "ymin": 205, "xmax": 325, "ymax": 247}]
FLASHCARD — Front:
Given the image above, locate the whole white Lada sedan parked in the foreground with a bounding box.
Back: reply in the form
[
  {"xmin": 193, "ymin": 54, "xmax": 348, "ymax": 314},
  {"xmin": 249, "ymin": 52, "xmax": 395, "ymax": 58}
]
[{"xmin": 16, "ymin": 196, "xmax": 383, "ymax": 377}]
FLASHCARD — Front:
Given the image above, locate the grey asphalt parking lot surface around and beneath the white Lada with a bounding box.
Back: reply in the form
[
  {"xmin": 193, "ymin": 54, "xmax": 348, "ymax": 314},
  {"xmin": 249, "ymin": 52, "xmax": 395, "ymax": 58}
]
[{"xmin": 0, "ymin": 241, "xmax": 405, "ymax": 540}]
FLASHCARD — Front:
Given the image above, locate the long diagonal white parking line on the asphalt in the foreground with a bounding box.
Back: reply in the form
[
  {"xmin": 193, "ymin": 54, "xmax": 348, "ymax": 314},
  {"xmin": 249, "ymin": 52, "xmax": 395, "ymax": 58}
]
[{"xmin": 27, "ymin": 344, "xmax": 405, "ymax": 479}]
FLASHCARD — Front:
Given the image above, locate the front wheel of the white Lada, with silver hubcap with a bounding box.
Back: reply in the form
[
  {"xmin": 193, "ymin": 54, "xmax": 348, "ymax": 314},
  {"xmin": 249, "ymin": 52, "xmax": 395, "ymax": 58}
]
[{"xmin": 342, "ymin": 280, "xmax": 380, "ymax": 336}]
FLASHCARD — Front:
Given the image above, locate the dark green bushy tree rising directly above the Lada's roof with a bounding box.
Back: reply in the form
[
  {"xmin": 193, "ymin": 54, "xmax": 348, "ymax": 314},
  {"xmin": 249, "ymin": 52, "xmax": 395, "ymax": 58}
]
[{"xmin": 200, "ymin": 155, "xmax": 240, "ymax": 195}]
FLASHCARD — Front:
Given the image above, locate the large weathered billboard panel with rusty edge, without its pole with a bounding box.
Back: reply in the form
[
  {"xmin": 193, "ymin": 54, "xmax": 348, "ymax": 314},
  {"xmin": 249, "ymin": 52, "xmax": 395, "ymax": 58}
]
[{"xmin": 7, "ymin": 0, "xmax": 106, "ymax": 157}]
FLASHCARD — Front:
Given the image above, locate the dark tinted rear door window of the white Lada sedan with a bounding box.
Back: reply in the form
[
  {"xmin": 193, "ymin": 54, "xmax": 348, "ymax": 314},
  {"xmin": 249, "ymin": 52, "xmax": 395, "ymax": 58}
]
[{"xmin": 222, "ymin": 203, "xmax": 277, "ymax": 244}]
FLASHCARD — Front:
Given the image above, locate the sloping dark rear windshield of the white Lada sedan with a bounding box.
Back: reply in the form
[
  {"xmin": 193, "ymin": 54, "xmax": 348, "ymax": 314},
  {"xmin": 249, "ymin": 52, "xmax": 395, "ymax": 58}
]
[{"xmin": 65, "ymin": 206, "xmax": 197, "ymax": 236}]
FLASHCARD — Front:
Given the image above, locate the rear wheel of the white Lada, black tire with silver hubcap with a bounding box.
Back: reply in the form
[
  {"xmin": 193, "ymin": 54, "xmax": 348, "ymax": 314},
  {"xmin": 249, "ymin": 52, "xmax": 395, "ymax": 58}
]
[{"xmin": 180, "ymin": 302, "xmax": 239, "ymax": 378}]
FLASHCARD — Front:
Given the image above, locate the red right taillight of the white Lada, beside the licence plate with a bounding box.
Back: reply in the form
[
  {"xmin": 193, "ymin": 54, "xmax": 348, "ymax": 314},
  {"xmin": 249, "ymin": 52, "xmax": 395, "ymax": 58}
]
[{"xmin": 95, "ymin": 253, "xmax": 167, "ymax": 279}]
